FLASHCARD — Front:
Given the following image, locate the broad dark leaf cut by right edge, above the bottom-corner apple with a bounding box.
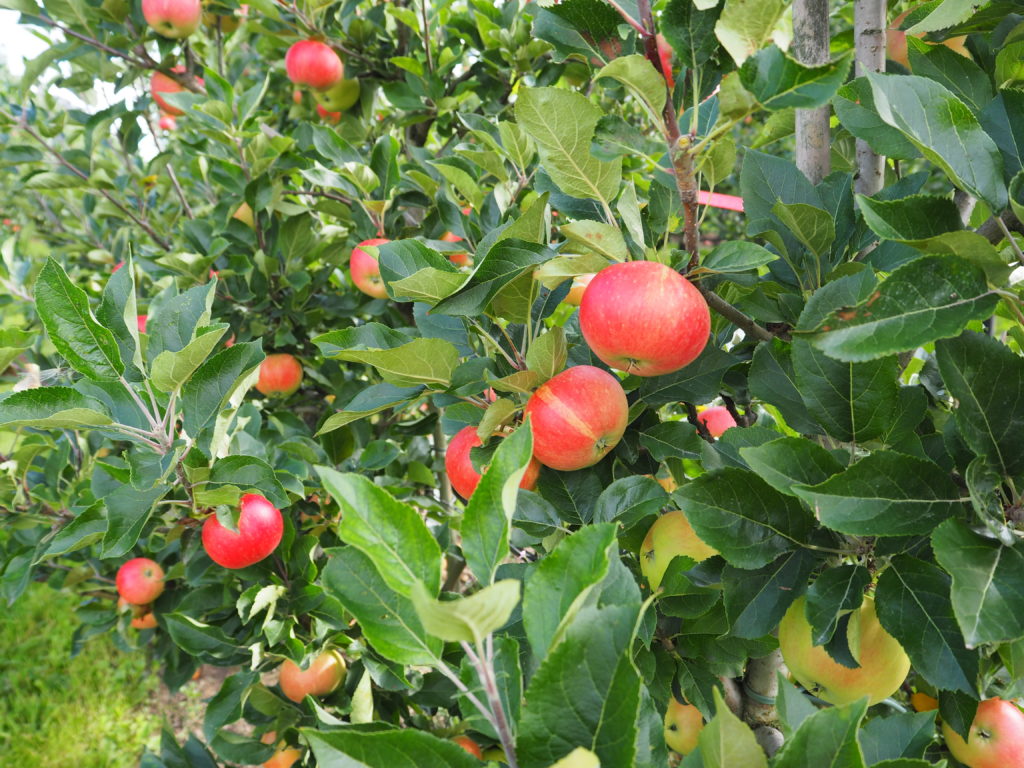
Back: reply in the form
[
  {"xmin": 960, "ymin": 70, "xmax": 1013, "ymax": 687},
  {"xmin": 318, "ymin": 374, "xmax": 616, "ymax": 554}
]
[{"xmin": 932, "ymin": 520, "xmax": 1024, "ymax": 648}]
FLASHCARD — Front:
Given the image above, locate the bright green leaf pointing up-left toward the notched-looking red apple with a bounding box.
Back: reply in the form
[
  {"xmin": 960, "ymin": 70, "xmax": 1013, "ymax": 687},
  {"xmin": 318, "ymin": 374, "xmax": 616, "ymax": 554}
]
[{"xmin": 315, "ymin": 466, "xmax": 441, "ymax": 597}]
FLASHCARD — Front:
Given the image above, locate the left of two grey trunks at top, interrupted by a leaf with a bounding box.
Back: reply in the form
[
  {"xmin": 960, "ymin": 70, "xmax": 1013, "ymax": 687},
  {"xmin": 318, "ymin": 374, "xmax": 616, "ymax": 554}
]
[{"xmin": 793, "ymin": 0, "xmax": 831, "ymax": 184}]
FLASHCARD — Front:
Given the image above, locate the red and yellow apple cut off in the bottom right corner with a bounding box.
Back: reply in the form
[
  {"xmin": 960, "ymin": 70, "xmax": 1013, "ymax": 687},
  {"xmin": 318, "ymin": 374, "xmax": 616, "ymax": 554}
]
[{"xmin": 942, "ymin": 698, "xmax": 1024, "ymax": 768}]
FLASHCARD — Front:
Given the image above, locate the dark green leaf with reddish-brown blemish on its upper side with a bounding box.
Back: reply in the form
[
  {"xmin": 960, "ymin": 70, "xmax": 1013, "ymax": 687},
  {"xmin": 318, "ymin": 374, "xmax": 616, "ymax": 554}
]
[{"xmin": 809, "ymin": 255, "xmax": 998, "ymax": 361}]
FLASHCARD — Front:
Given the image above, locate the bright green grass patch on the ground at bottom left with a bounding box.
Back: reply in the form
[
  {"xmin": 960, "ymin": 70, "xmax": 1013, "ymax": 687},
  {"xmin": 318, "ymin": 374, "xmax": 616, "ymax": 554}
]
[{"xmin": 0, "ymin": 585, "xmax": 161, "ymax": 768}]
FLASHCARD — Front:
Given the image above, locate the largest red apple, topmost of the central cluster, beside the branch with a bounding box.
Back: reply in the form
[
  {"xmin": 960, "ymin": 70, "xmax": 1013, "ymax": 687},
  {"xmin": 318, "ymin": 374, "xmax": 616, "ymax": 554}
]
[{"xmin": 580, "ymin": 261, "xmax": 711, "ymax": 376}]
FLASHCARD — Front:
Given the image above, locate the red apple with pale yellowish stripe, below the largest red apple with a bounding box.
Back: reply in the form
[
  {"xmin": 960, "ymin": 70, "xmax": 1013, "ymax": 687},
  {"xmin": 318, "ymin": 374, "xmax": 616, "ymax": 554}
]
[{"xmin": 524, "ymin": 366, "xmax": 630, "ymax": 472}]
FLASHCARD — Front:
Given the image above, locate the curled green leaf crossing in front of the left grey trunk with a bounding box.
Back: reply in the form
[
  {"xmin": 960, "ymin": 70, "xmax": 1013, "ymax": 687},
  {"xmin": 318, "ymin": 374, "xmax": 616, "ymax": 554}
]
[{"xmin": 739, "ymin": 45, "xmax": 853, "ymax": 111}]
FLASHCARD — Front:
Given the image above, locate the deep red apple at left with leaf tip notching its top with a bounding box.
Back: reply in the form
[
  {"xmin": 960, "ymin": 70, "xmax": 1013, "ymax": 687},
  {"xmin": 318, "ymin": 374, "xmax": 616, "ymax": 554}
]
[{"xmin": 203, "ymin": 494, "xmax": 285, "ymax": 569}]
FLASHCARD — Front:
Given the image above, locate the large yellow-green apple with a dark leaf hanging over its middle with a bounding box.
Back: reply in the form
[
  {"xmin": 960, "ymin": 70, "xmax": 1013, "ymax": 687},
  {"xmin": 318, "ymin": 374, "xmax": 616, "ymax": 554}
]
[{"xmin": 778, "ymin": 597, "xmax": 910, "ymax": 707}]
